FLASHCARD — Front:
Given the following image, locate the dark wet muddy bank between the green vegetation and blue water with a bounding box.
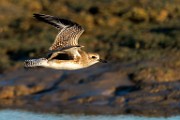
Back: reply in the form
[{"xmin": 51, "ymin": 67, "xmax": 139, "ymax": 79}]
[{"xmin": 0, "ymin": 61, "xmax": 180, "ymax": 116}]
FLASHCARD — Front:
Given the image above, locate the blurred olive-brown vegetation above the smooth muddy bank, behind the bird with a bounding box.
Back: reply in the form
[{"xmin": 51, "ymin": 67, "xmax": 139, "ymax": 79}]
[{"xmin": 0, "ymin": 0, "xmax": 180, "ymax": 73}]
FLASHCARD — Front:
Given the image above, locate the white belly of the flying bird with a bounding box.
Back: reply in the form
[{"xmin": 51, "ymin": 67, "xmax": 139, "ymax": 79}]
[{"xmin": 48, "ymin": 62, "xmax": 83, "ymax": 70}]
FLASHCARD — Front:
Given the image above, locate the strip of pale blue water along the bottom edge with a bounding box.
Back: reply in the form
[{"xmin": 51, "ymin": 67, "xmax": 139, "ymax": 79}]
[{"xmin": 0, "ymin": 110, "xmax": 180, "ymax": 120}]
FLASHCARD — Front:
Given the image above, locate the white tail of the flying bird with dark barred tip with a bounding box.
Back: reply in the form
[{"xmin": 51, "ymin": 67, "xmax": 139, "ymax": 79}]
[{"xmin": 24, "ymin": 58, "xmax": 48, "ymax": 68}]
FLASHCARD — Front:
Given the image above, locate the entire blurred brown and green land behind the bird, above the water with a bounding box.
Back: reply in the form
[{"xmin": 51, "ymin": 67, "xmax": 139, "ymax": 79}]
[{"xmin": 0, "ymin": 0, "xmax": 180, "ymax": 116}]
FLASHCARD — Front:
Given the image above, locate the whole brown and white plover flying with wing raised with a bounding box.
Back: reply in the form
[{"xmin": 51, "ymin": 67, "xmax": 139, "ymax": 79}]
[{"xmin": 24, "ymin": 14, "xmax": 106, "ymax": 70}]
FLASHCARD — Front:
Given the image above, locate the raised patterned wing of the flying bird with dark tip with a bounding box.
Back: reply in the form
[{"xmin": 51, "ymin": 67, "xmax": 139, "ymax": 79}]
[{"xmin": 34, "ymin": 14, "xmax": 84, "ymax": 51}]
